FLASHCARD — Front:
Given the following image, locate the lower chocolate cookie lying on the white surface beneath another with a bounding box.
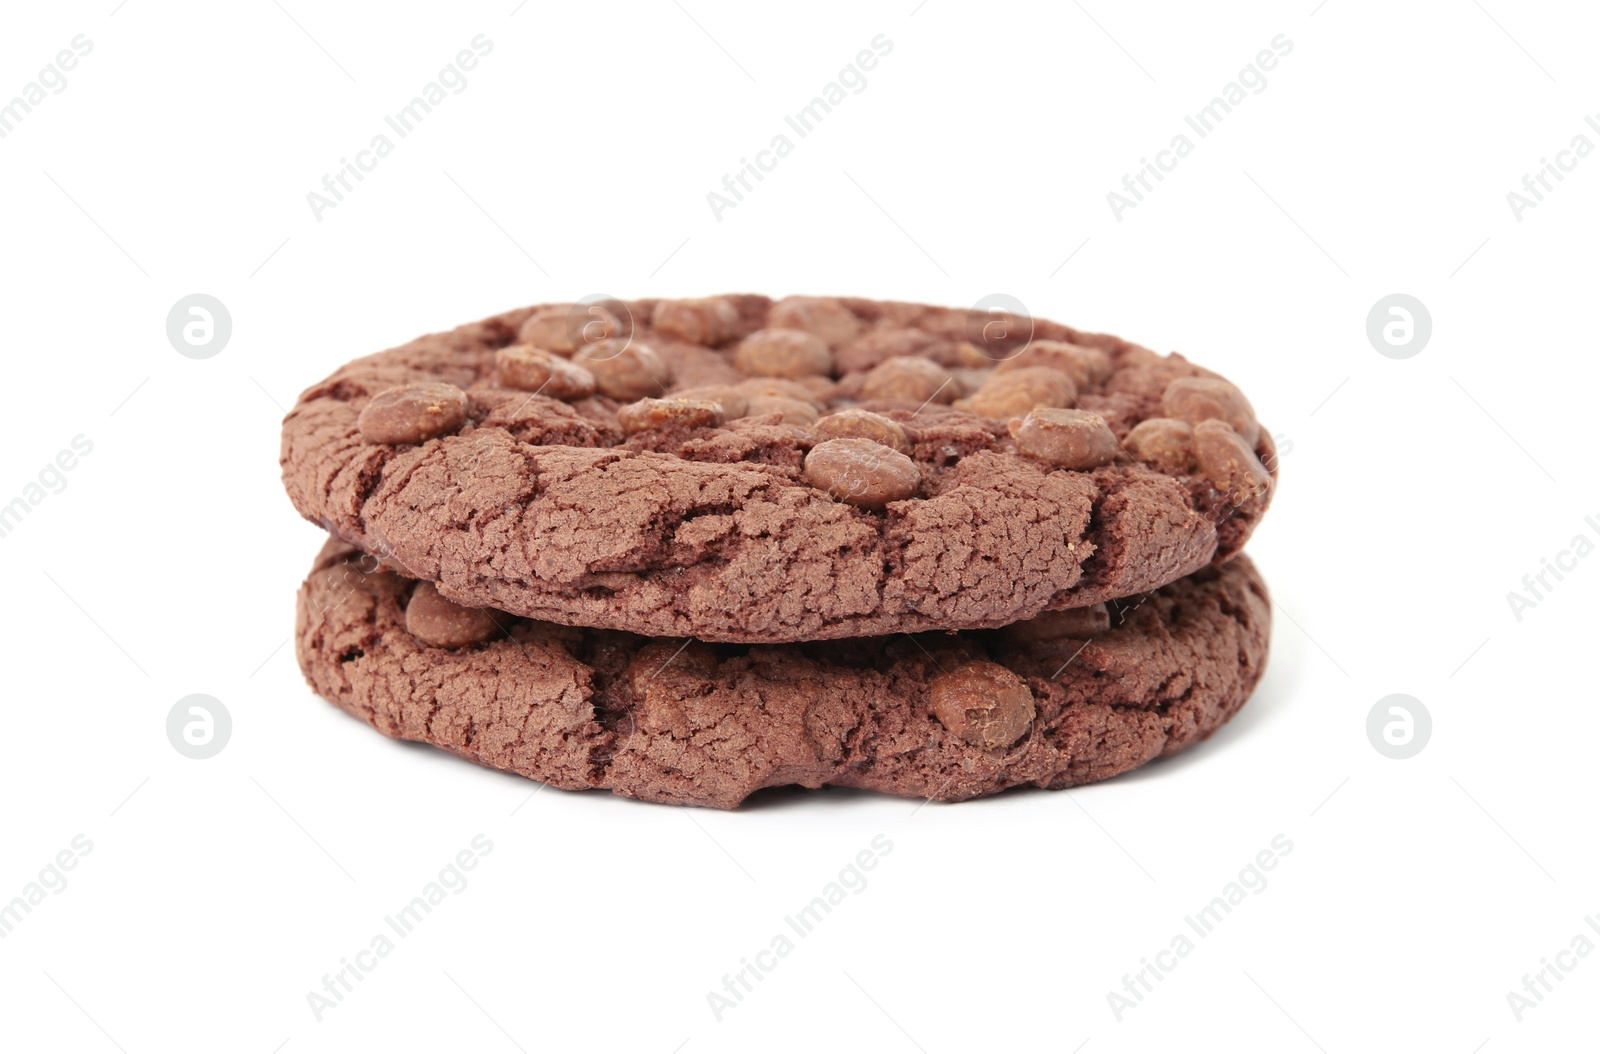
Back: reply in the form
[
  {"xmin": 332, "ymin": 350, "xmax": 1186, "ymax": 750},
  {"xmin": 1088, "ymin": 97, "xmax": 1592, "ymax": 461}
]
[{"xmin": 294, "ymin": 541, "xmax": 1272, "ymax": 808}]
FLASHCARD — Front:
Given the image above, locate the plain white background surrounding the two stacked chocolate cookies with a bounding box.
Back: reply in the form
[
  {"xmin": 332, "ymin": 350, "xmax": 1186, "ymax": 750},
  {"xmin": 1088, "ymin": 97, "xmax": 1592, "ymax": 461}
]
[{"xmin": 0, "ymin": 0, "xmax": 1600, "ymax": 1054}]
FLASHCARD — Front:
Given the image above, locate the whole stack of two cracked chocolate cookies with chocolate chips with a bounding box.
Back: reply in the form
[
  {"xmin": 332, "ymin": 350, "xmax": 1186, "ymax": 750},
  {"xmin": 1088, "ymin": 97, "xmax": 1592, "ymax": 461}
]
[{"xmin": 282, "ymin": 294, "xmax": 1277, "ymax": 808}]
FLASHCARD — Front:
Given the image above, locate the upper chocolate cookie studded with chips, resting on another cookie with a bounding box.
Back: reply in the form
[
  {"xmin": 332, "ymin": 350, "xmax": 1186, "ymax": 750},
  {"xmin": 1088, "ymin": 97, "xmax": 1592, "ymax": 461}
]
[{"xmin": 282, "ymin": 294, "xmax": 1277, "ymax": 641}]
